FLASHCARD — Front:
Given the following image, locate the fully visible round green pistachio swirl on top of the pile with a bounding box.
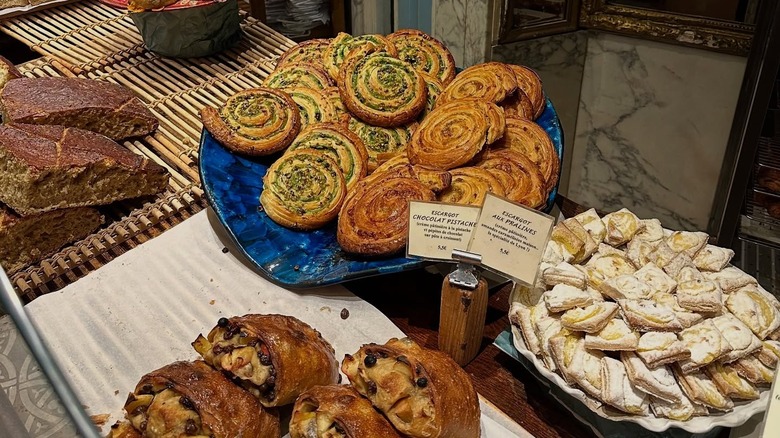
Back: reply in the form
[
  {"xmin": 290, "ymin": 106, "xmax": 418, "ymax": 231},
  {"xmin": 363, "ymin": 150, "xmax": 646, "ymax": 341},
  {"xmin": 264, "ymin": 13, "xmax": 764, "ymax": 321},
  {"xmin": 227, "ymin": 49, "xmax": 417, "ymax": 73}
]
[{"xmin": 338, "ymin": 48, "xmax": 428, "ymax": 128}]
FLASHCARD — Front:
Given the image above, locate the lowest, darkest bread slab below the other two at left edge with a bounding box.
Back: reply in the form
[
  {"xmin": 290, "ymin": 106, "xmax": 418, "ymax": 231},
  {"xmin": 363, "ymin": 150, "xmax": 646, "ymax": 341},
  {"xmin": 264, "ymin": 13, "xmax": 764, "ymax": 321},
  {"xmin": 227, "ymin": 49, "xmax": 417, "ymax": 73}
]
[{"xmin": 0, "ymin": 204, "xmax": 102, "ymax": 275}]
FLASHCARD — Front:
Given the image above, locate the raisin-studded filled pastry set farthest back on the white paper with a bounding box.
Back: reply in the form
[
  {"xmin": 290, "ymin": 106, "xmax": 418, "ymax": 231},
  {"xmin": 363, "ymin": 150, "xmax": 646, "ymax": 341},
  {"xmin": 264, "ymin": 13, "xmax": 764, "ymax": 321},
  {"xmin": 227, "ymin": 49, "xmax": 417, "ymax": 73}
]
[{"xmin": 192, "ymin": 315, "xmax": 339, "ymax": 408}]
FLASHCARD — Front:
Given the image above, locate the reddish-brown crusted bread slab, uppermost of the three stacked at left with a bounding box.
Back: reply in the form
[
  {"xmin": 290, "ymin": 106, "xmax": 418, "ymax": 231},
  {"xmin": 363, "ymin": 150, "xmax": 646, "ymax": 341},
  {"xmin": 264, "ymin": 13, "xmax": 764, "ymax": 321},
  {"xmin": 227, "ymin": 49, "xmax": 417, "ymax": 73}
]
[{"xmin": 0, "ymin": 78, "xmax": 157, "ymax": 140}]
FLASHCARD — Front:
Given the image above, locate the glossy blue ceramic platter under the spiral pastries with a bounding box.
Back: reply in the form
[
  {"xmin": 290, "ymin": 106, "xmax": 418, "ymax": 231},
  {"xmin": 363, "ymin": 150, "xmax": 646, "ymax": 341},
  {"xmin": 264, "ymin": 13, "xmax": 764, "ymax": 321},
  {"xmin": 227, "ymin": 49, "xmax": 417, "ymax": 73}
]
[{"xmin": 200, "ymin": 99, "xmax": 563, "ymax": 288}]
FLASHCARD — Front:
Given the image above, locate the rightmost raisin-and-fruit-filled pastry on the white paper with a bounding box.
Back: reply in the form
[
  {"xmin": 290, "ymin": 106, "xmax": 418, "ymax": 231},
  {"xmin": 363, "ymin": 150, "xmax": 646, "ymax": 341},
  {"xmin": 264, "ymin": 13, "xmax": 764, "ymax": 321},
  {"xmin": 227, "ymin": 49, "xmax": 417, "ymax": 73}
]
[{"xmin": 341, "ymin": 338, "xmax": 480, "ymax": 438}]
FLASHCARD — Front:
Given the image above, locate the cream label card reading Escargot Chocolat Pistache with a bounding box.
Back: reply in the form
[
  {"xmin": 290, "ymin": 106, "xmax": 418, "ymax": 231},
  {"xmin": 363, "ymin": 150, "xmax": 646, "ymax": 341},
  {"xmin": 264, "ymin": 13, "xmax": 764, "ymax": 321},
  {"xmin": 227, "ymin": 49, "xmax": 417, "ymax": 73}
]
[{"xmin": 406, "ymin": 201, "xmax": 480, "ymax": 260}]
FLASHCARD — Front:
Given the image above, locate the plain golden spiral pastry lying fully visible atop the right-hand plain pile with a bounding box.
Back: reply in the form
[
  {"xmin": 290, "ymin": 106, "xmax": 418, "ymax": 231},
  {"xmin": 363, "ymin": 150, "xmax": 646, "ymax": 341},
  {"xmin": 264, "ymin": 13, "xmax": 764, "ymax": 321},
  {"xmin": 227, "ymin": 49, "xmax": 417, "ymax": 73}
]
[{"xmin": 407, "ymin": 99, "xmax": 504, "ymax": 170}]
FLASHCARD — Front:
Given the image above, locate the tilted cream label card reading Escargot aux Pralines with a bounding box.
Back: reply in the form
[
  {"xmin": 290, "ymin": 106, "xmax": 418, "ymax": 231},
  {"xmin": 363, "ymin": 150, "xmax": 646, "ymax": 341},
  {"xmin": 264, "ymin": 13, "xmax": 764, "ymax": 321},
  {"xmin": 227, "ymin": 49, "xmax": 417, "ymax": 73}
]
[{"xmin": 469, "ymin": 193, "xmax": 555, "ymax": 284}]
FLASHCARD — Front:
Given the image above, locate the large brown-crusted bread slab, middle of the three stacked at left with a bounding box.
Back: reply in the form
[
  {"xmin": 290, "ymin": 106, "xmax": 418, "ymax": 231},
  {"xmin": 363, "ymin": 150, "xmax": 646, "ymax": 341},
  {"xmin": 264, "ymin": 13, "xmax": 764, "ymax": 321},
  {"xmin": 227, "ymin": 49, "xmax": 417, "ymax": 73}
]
[{"xmin": 0, "ymin": 124, "xmax": 168, "ymax": 215}]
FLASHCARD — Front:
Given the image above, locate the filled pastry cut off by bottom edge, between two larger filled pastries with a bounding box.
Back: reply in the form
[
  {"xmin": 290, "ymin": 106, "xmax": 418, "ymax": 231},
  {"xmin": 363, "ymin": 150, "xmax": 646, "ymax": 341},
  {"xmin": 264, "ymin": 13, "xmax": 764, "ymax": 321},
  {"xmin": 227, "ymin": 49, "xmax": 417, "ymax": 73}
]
[{"xmin": 290, "ymin": 385, "xmax": 401, "ymax": 438}]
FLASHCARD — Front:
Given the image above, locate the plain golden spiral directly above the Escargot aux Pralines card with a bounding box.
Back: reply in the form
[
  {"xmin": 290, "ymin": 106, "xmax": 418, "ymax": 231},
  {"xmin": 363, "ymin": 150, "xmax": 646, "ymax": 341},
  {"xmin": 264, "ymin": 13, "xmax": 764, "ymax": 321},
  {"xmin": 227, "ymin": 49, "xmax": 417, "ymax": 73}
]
[{"xmin": 477, "ymin": 149, "xmax": 548, "ymax": 208}]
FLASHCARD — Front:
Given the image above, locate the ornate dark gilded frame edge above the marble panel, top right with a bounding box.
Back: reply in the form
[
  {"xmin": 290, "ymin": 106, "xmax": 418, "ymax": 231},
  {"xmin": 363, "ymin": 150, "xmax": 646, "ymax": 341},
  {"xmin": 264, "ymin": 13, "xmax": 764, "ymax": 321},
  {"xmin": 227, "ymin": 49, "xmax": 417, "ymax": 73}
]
[{"xmin": 580, "ymin": 0, "xmax": 756, "ymax": 56}]
